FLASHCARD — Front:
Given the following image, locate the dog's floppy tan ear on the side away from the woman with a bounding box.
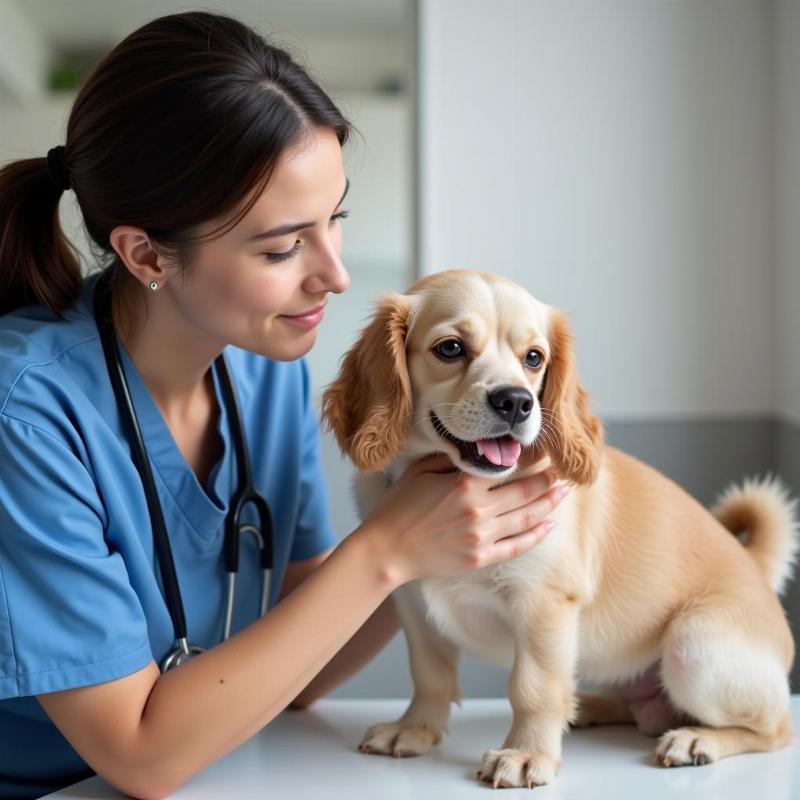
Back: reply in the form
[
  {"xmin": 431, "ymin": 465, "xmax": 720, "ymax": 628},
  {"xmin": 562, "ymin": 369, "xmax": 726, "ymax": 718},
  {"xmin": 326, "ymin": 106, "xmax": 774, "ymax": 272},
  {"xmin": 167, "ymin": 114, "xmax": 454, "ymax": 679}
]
[{"xmin": 534, "ymin": 310, "xmax": 604, "ymax": 485}]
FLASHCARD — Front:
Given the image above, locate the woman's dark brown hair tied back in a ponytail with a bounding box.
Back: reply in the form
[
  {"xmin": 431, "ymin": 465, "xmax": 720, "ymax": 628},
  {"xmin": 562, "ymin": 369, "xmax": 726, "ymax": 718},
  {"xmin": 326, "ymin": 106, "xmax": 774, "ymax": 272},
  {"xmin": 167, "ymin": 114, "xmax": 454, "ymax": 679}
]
[{"xmin": 0, "ymin": 11, "xmax": 352, "ymax": 319}]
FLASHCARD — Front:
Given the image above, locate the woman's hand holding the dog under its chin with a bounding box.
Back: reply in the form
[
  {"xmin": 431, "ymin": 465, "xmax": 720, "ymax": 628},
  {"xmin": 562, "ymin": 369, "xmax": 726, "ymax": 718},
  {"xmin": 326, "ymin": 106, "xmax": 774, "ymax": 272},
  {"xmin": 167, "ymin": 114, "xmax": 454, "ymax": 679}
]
[{"xmin": 360, "ymin": 453, "xmax": 569, "ymax": 586}]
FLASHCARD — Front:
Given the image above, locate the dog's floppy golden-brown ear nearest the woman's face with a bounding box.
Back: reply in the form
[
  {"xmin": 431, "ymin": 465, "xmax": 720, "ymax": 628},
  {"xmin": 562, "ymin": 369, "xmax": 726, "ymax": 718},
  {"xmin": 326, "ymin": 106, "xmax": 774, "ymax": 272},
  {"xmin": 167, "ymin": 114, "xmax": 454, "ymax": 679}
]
[{"xmin": 322, "ymin": 292, "xmax": 412, "ymax": 472}]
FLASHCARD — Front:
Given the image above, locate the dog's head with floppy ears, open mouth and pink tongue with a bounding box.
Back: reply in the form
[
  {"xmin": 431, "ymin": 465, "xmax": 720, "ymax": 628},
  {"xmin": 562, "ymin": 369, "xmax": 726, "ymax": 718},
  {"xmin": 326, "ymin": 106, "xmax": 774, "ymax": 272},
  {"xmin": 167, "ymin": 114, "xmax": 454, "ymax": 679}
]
[{"xmin": 322, "ymin": 270, "xmax": 603, "ymax": 484}]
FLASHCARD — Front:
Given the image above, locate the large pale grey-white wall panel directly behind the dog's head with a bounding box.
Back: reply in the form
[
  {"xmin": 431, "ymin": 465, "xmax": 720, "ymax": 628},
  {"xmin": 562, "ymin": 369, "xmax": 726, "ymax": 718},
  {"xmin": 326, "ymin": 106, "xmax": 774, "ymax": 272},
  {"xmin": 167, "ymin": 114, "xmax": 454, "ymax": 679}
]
[{"xmin": 419, "ymin": 0, "xmax": 776, "ymax": 419}]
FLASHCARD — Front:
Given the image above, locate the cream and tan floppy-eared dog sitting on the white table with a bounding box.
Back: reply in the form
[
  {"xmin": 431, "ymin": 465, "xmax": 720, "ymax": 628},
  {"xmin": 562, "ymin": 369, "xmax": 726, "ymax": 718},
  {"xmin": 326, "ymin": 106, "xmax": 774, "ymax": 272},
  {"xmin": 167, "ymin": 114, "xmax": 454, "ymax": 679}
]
[{"xmin": 321, "ymin": 270, "xmax": 798, "ymax": 788}]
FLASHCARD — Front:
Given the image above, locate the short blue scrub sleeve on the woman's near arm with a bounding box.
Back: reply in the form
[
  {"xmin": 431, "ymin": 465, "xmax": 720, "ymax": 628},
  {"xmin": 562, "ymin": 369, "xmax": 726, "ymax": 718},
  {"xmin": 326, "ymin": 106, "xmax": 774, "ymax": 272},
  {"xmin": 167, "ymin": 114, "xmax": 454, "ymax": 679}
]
[{"xmin": 0, "ymin": 415, "xmax": 152, "ymax": 697}]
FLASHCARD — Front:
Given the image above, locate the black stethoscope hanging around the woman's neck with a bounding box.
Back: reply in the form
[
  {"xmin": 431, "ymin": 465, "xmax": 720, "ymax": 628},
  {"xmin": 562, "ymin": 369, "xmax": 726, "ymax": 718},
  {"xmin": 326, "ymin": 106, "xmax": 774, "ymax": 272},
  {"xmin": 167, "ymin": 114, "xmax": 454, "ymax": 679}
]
[{"xmin": 94, "ymin": 270, "xmax": 274, "ymax": 673}]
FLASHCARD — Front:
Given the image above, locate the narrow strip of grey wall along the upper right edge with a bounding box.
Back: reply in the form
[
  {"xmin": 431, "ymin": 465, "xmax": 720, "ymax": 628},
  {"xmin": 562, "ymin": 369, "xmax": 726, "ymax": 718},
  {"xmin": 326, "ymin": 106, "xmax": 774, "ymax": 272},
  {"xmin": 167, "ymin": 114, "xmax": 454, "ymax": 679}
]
[{"xmin": 773, "ymin": 0, "xmax": 800, "ymax": 425}]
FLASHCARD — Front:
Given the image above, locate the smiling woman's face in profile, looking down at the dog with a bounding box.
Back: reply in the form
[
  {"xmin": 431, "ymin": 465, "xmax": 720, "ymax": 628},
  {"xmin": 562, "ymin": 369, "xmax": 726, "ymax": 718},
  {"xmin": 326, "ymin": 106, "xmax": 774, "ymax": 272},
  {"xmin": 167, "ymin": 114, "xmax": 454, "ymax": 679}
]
[{"xmin": 165, "ymin": 128, "xmax": 350, "ymax": 361}]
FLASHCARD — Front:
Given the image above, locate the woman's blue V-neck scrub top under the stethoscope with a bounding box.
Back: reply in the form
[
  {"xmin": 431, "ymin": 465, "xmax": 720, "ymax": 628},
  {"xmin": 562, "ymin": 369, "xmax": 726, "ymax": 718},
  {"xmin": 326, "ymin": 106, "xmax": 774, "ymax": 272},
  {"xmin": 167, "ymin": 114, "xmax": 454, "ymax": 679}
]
[{"xmin": 0, "ymin": 272, "xmax": 338, "ymax": 798}]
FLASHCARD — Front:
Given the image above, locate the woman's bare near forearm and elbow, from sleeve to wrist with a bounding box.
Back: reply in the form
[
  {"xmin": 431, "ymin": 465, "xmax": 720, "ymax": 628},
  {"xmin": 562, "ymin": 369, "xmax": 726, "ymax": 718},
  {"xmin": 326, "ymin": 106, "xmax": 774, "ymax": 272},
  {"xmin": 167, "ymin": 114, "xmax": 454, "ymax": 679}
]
[{"xmin": 39, "ymin": 528, "xmax": 397, "ymax": 798}]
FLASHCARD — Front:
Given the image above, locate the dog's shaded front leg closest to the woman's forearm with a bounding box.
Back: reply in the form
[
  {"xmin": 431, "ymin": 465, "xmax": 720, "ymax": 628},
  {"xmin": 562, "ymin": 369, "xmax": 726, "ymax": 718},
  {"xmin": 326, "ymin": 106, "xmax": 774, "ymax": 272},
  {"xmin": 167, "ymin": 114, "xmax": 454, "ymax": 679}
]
[{"xmin": 358, "ymin": 581, "xmax": 461, "ymax": 757}]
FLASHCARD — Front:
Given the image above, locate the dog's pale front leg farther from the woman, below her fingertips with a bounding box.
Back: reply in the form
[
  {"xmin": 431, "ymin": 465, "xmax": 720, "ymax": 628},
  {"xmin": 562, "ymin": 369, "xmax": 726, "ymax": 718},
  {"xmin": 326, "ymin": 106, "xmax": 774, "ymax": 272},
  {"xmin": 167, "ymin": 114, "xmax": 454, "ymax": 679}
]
[{"xmin": 477, "ymin": 590, "xmax": 578, "ymax": 788}]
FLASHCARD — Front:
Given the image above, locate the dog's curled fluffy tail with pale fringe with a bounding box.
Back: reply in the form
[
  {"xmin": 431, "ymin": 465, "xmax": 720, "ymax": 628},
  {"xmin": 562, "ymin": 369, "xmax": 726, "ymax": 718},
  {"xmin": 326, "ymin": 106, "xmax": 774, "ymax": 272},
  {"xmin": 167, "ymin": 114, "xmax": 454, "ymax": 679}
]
[{"xmin": 711, "ymin": 474, "xmax": 800, "ymax": 594}]
